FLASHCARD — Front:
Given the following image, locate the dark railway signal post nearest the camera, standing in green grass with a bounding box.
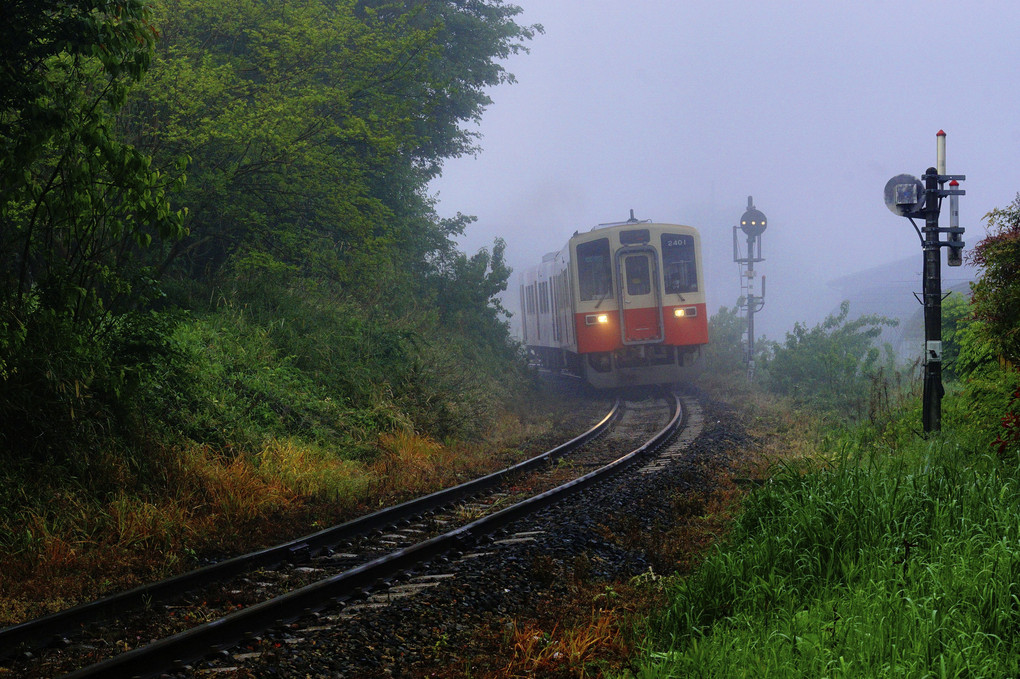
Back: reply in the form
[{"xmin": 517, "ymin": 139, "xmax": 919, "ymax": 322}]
[{"xmin": 885, "ymin": 129, "xmax": 967, "ymax": 433}]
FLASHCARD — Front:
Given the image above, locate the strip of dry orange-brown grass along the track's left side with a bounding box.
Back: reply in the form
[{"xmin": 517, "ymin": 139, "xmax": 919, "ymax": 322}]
[{"xmin": 0, "ymin": 407, "xmax": 546, "ymax": 626}]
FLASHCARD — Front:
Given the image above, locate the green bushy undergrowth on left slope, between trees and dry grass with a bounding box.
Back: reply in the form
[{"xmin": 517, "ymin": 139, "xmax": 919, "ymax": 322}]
[{"xmin": 163, "ymin": 253, "xmax": 523, "ymax": 457}]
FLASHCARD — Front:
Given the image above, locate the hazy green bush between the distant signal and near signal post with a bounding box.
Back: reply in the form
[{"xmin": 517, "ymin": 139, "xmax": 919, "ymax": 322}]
[{"xmin": 763, "ymin": 302, "xmax": 897, "ymax": 416}]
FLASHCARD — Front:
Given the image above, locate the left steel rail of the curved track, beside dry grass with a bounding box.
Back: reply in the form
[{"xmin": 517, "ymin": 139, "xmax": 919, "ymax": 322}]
[{"xmin": 0, "ymin": 399, "xmax": 620, "ymax": 658}]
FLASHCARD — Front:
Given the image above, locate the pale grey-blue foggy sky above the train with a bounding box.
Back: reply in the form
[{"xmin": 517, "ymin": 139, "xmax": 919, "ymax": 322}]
[{"xmin": 431, "ymin": 0, "xmax": 1020, "ymax": 340}]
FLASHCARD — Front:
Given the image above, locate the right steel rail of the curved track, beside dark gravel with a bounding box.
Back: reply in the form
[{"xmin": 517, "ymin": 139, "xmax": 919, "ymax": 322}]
[{"xmin": 65, "ymin": 395, "xmax": 683, "ymax": 679}]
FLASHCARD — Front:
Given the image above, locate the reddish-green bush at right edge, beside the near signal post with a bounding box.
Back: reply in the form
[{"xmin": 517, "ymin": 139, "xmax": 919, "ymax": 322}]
[{"xmin": 972, "ymin": 194, "xmax": 1020, "ymax": 365}]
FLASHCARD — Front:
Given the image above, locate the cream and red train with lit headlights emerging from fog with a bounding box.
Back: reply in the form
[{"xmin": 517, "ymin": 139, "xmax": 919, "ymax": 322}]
[{"xmin": 520, "ymin": 210, "xmax": 708, "ymax": 389}]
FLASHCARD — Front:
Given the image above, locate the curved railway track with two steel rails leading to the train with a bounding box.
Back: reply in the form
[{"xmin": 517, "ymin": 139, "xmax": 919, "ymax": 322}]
[{"xmin": 0, "ymin": 389, "xmax": 682, "ymax": 677}]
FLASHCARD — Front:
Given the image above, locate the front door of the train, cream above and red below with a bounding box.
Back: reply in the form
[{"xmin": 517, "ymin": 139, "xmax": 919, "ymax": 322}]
[{"xmin": 617, "ymin": 249, "xmax": 662, "ymax": 345}]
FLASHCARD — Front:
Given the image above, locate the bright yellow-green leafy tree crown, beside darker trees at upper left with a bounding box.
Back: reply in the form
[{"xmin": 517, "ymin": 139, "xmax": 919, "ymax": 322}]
[{"xmin": 121, "ymin": 0, "xmax": 397, "ymax": 282}]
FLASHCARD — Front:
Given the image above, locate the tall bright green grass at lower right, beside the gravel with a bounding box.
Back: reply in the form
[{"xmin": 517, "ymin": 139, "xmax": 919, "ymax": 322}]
[{"xmin": 638, "ymin": 436, "xmax": 1020, "ymax": 678}]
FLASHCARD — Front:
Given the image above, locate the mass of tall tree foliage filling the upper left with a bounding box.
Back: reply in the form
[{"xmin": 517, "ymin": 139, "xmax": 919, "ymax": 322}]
[{"xmin": 0, "ymin": 0, "xmax": 537, "ymax": 456}]
